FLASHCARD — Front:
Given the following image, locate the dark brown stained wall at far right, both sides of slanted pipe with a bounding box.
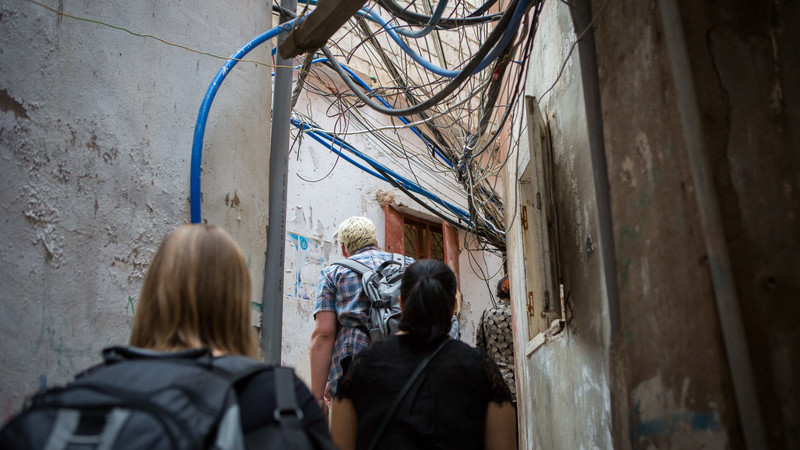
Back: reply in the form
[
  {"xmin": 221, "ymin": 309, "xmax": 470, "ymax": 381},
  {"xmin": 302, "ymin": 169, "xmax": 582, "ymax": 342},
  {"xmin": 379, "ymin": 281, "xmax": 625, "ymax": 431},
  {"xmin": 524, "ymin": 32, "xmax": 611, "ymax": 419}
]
[{"xmin": 593, "ymin": 1, "xmax": 800, "ymax": 448}]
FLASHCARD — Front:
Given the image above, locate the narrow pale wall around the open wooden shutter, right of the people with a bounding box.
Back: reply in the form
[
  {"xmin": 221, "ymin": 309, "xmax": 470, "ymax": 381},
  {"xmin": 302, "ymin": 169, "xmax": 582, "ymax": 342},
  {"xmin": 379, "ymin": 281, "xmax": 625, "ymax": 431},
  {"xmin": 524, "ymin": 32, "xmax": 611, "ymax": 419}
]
[{"xmin": 505, "ymin": 2, "xmax": 613, "ymax": 449}]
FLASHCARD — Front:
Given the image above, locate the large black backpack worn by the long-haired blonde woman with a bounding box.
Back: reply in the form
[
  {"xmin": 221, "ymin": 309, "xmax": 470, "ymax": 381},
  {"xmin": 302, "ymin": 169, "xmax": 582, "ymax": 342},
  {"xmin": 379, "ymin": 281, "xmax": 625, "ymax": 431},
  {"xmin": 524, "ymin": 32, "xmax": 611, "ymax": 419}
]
[{"xmin": 0, "ymin": 347, "xmax": 335, "ymax": 450}]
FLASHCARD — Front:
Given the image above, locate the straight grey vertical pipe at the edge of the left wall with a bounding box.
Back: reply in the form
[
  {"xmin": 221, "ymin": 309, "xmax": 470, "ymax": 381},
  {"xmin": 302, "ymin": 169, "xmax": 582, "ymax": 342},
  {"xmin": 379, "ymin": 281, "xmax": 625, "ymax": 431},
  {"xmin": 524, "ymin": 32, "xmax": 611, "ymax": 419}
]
[{"xmin": 261, "ymin": 0, "xmax": 297, "ymax": 365}]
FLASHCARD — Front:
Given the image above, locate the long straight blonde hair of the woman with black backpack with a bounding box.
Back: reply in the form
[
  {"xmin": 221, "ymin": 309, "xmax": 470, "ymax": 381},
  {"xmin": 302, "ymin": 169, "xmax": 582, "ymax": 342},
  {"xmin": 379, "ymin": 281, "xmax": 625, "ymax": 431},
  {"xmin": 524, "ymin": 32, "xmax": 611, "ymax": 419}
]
[{"xmin": 130, "ymin": 224, "xmax": 259, "ymax": 358}]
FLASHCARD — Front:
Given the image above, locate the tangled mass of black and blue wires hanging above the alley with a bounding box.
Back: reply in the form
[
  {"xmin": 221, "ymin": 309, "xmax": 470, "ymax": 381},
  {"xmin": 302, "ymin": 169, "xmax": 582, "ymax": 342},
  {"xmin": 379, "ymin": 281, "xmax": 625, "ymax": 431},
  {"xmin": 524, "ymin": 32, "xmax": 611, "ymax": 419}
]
[{"xmin": 273, "ymin": 0, "xmax": 543, "ymax": 253}]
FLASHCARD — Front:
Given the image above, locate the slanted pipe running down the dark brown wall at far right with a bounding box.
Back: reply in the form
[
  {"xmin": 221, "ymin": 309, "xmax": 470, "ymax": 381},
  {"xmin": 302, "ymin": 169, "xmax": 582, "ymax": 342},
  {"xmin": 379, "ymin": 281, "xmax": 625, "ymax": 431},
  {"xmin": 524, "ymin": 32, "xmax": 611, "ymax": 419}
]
[{"xmin": 658, "ymin": 0, "xmax": 768, "ymax": 449}]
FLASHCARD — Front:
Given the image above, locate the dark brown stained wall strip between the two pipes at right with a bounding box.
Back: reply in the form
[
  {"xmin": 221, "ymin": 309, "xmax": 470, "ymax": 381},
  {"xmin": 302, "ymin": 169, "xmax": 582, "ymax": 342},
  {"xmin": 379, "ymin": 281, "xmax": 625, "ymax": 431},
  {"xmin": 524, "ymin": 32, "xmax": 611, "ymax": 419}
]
[{"xmin": 597, "ymin": 2, "xmax": 737, "ymax": 442}]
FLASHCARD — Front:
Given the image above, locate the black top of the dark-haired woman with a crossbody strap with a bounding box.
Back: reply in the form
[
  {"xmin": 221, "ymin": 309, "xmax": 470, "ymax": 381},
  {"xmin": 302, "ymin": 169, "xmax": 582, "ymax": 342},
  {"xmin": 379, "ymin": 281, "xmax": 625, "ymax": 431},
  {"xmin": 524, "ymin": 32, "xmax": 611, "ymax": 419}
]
[{"xmin": 336, "ymin": 335, "xmax": 511, "ymax": 449}]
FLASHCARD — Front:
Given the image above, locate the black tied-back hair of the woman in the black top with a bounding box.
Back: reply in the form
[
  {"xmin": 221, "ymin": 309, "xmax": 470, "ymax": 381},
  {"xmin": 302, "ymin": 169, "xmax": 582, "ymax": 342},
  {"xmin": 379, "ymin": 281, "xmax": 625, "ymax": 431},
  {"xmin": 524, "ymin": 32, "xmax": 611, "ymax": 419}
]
[{"xmin": 400, "ymin": 259, "xmax": 457, "ymax": 342}]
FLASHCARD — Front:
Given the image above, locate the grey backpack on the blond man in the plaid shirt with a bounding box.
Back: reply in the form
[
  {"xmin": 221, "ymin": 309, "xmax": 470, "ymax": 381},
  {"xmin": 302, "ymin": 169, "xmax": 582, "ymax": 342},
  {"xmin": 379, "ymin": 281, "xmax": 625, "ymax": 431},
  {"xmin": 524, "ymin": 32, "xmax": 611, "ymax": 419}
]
[{"xmin": 333, "ymin": 253, "xmax": 408, "ymax": 342}]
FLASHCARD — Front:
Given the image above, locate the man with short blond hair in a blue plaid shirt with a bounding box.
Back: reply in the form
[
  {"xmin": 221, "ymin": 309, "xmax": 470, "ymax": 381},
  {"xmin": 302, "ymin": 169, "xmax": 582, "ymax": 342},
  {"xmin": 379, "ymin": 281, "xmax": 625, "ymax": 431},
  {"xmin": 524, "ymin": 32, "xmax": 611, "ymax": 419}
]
[{"xmin": 309, "ymin": 216, "xmax": 414, "ymax": 416}]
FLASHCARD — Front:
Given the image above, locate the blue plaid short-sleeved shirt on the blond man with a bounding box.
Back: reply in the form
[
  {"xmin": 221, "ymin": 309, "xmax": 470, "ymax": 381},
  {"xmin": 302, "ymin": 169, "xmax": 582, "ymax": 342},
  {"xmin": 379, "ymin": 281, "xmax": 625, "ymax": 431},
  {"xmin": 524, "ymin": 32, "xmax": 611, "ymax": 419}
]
[{"xmin": 314, "ymin": 246, "xmax": 414, "ymax": 397}]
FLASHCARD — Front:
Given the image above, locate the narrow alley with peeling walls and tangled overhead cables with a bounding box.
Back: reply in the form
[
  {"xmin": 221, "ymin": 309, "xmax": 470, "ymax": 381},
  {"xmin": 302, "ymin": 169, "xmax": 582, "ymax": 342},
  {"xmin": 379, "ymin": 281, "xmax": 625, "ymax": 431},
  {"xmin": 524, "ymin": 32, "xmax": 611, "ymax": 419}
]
[{"xmin": 0, "ymin": 0, "xmax": 800, "ymax": 450}]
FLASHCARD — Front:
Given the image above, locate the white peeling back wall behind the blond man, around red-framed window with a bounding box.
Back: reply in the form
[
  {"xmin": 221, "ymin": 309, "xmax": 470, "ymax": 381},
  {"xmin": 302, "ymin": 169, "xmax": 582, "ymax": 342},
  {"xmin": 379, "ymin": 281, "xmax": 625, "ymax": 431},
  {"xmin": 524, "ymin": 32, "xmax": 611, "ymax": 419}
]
[{"xmin": 281, "ymin": 69, "xmax": 502, "ymax": 381}]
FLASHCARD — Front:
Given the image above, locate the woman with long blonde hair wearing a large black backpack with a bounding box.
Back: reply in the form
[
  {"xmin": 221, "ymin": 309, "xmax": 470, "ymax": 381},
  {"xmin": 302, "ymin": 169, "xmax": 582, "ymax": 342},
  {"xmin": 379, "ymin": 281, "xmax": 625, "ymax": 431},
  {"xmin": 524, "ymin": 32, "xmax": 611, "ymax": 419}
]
[{"xmin": 0, "ymin": 224, "xmax": 334, "ymax": 450}]
